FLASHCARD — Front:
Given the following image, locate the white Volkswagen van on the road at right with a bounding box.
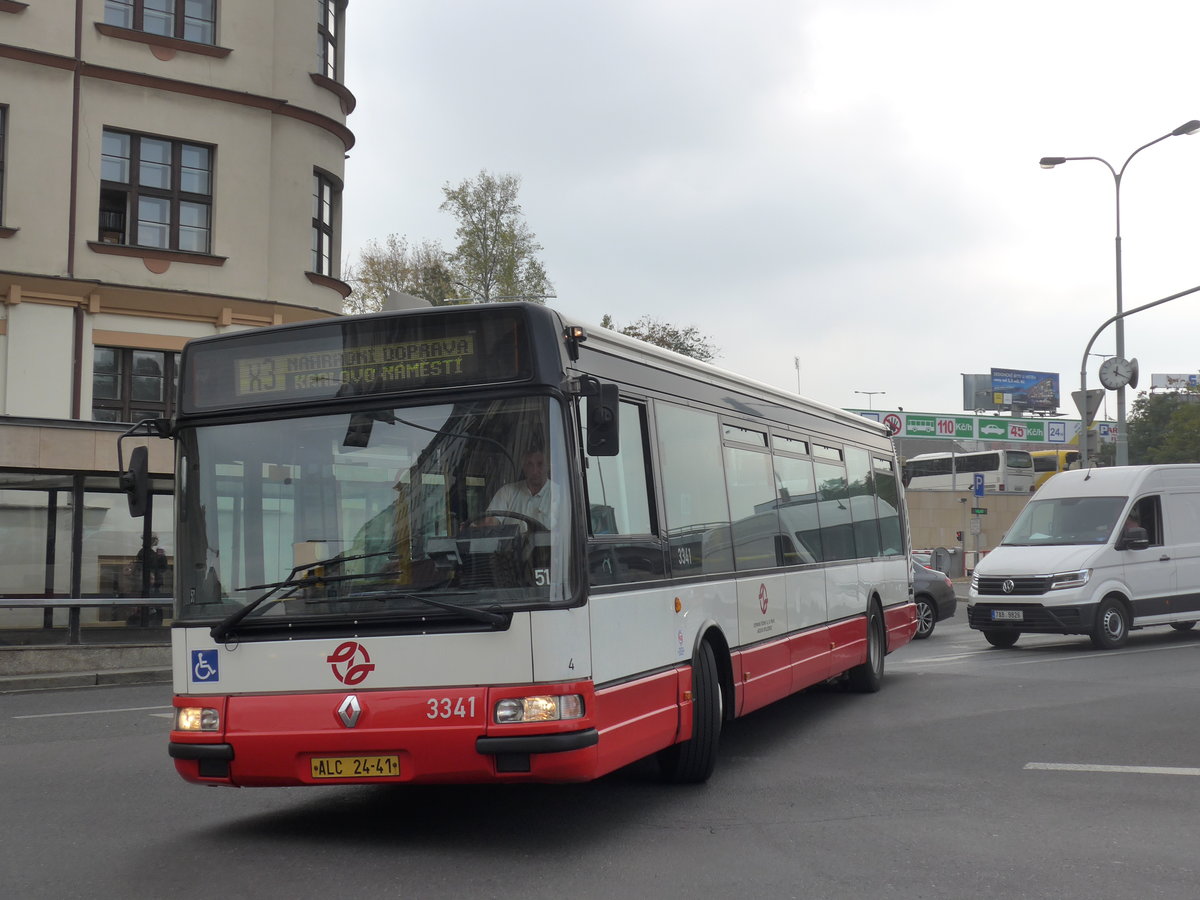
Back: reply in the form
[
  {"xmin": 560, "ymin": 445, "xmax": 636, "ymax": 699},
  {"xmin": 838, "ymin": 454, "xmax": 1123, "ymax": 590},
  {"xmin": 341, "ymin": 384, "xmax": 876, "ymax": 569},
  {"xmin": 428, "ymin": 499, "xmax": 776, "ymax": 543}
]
[{"xmin": 967, "ymin": 466, "xmax": 1200, "ymax": 649}]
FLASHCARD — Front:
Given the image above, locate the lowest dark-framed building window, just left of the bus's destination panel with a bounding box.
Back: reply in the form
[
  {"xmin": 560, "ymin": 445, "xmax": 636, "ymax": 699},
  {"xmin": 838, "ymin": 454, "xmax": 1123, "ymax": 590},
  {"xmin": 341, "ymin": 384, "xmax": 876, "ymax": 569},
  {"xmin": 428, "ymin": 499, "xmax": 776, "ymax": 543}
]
[{"xmin": 91, "ymin": 347, "xmax": 179, "ymax": 422}]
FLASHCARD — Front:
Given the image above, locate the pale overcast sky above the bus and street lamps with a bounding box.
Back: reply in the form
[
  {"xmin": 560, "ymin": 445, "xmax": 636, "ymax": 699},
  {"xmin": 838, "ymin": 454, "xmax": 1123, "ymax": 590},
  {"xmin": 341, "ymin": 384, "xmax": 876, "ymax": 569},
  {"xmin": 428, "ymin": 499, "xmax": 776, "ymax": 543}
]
[{"xmin": 343, "ymin": 0, "xmax": 1200, "ymax": 414}]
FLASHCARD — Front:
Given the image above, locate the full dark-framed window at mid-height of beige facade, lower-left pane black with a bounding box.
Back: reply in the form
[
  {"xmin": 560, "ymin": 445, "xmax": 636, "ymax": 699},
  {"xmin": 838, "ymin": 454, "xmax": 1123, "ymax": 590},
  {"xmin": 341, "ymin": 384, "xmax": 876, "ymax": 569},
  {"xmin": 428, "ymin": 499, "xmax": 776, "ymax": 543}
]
[{"xmin": 100, "ymin": 128, "xmax": 214, "ymax": 253}]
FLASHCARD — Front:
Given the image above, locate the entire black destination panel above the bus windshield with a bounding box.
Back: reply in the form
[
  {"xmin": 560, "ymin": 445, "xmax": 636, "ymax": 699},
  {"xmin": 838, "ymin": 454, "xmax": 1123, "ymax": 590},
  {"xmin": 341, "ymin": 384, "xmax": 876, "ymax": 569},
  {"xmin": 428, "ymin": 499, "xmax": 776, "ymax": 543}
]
[{"xmin": 180, "ymin": 308, "xmax": 532, "ymax": 415}]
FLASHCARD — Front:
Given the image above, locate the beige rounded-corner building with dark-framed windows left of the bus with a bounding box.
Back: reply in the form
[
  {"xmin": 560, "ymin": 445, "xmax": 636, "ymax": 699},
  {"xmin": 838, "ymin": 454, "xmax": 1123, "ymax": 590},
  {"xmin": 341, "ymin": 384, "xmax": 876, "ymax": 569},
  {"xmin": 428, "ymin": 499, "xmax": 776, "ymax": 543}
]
[{"xmin": 0, "ymin": 0, "xmax": 354, "ymax": 629}]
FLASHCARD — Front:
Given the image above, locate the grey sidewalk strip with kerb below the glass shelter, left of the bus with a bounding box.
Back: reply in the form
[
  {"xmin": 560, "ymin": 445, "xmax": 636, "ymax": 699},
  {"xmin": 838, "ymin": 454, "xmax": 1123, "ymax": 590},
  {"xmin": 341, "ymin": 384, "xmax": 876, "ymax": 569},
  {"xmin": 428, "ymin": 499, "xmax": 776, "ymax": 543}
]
[{"xmin": 0, "ymin": 629, "xmax": 170, "ymax": 694}]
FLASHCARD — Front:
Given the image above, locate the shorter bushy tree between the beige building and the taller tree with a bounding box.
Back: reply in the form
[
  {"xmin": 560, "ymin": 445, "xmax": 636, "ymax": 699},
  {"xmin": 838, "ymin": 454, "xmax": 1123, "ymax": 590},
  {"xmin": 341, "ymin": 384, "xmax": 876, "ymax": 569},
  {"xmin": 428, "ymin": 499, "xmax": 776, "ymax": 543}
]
[{"xmin": 342, "ymin": 234, "xmax": 455, "ymax": 314}]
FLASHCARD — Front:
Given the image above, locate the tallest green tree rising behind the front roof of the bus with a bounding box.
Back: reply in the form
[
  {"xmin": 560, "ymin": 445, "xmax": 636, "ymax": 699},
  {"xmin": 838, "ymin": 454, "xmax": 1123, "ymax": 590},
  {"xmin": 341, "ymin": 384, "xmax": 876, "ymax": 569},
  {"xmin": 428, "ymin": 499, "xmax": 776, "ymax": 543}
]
[{"xmin": 440, "ymin": 170, "xmax": 554, "ymax": 304}]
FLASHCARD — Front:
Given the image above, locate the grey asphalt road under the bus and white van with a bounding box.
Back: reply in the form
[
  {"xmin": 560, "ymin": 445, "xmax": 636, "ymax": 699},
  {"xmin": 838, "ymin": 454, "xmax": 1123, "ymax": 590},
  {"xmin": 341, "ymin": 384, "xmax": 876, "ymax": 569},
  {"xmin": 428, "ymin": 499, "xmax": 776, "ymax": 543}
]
[{"xmin": 0, "ymin": 607, "xmax": 1200, "ymax": 900}]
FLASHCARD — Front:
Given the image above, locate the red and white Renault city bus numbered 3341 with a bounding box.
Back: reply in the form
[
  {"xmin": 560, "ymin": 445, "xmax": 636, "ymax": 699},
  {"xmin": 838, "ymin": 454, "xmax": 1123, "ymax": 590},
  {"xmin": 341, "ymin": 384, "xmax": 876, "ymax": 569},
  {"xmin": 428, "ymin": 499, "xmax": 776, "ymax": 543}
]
[{"xmin": 125, "ymin": 302, "xmax": 916, "ymax": 786}]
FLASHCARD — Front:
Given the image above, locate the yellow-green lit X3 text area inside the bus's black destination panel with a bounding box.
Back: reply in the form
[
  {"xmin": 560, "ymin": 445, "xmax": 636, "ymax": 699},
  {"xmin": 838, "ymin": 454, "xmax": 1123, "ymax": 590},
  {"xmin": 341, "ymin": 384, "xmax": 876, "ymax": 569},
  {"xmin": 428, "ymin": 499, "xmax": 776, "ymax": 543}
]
[{"xmin": 234, "ymin": 335, "xmax": 475, "ymax": 397}]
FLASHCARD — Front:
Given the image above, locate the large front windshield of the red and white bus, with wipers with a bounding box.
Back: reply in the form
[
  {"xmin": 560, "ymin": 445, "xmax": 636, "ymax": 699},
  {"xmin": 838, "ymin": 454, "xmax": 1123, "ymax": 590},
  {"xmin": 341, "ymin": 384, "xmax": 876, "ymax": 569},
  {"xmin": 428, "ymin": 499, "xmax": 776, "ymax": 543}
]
[{"xmin": 176, "ymin": 396, "xmax": 576, "ymax": 630}]
